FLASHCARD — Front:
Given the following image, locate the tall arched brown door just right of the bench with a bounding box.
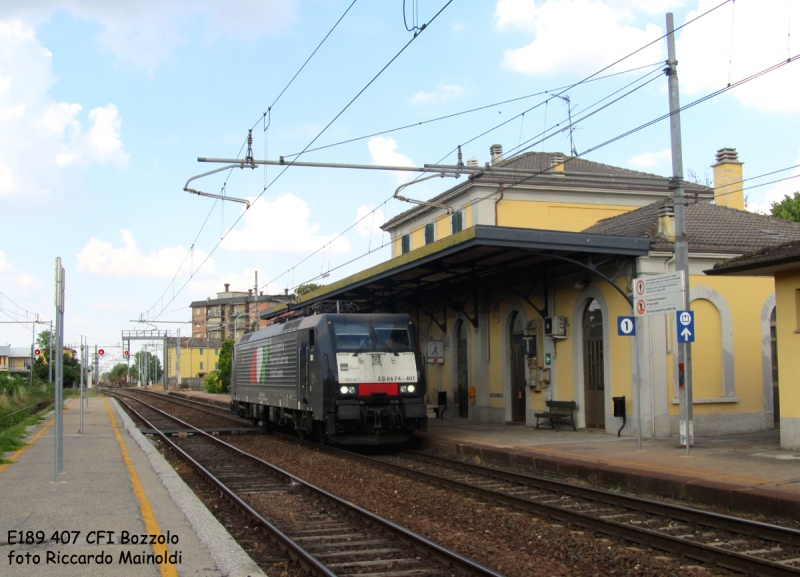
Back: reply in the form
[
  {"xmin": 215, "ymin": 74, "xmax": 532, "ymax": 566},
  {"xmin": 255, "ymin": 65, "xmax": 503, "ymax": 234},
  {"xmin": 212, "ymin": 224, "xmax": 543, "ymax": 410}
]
[{"xmin": 583, "ymin": 299, "xmax": 606, "ymax": 430}]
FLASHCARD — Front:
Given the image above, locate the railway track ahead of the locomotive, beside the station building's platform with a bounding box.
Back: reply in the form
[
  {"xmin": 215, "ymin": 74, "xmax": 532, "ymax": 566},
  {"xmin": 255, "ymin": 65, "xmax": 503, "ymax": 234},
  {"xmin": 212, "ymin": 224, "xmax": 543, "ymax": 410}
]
[{"xmin": 331, "ymin": 449, "xmax": 800, "ymax": 577}]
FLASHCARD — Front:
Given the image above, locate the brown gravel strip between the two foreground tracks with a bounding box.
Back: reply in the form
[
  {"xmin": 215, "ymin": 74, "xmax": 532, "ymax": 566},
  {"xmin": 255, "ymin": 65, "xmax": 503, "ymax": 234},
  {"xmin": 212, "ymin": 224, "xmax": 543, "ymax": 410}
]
[{"xmin": 225, "ymin": 436, "xmax": 735, "ymax": 577}]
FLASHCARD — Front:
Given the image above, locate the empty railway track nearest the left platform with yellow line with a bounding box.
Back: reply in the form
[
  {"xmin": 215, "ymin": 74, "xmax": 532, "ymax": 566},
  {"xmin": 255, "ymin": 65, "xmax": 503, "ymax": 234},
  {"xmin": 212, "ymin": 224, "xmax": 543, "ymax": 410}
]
[{"xmin": 109, "ymin": 391, "xmax": 502, "ymax": 577}]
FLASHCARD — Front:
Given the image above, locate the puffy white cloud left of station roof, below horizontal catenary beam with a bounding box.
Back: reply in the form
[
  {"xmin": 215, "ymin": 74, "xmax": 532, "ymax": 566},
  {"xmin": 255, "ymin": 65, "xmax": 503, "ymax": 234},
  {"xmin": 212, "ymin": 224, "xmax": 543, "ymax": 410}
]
[{"xmin": 222, "ymin": 193, "xmax": 350, "ymax": 253}]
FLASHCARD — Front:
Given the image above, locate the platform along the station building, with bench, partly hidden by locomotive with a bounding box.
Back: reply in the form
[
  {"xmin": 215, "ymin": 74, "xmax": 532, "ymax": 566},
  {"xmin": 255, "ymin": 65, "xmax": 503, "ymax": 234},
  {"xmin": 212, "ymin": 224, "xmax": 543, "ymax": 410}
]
[{"xmin": 173, "ymin": 391, "xmax": 800, "ymax": 520}]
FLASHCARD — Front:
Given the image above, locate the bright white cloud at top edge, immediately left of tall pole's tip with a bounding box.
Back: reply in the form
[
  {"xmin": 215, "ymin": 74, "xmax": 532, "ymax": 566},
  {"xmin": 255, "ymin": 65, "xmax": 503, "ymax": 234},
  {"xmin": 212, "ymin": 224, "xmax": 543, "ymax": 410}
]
[{"xmin": 495, "ymin": 0, "xmax": 664, "ymax": 75}]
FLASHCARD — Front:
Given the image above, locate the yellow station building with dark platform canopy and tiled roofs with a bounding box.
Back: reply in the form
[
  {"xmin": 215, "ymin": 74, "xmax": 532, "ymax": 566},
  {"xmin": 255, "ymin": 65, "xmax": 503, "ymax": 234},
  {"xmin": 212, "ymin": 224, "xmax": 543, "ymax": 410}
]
[{"xmin": 262, "ymin": 145, "xmax": 800, "ymax": 437}]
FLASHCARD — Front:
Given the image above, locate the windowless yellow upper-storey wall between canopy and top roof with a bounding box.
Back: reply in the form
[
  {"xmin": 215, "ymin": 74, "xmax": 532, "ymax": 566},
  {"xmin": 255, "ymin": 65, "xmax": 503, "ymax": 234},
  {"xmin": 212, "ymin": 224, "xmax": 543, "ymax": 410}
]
[{"xmin": 497, "ymin": 200, "xmax": 637, "ymax": 232}]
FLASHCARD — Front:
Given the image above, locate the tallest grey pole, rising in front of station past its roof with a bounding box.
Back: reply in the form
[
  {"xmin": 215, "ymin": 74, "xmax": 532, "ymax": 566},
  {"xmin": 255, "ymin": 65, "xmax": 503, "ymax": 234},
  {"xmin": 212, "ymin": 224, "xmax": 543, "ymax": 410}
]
[{"xmin": 666, "ymin": 12, "xmax": 694, "ymax": 456}]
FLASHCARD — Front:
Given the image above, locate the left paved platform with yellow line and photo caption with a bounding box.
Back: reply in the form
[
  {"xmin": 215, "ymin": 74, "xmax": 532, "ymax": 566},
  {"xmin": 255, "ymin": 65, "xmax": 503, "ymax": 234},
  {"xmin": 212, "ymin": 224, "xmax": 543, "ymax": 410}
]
[{"xmin": 0, "ymin": 397, "xmax": 264, "ymax": 577}]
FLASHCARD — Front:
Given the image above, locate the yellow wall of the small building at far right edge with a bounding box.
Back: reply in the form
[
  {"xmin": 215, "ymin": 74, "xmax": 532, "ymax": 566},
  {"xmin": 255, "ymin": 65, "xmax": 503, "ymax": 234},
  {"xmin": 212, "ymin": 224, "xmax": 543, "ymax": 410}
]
[{"xmin": 775, "ymin": 269, "xmax": 800, "ymax": 419}]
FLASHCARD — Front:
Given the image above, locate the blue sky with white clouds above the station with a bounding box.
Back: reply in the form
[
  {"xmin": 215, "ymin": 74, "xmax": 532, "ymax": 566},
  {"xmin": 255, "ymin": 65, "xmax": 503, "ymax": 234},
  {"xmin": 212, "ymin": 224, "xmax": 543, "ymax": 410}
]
[{"xmin": 0, "ymin": 0, "xmax": 800, "ymax": 366}]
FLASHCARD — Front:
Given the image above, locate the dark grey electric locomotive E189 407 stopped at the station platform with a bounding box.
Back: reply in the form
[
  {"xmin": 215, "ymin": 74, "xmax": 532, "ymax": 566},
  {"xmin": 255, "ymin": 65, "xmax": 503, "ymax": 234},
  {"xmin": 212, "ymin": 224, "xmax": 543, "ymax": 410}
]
[{"xmin": 231, "ymin": 304, "xmax": 428, "ymax": 445}]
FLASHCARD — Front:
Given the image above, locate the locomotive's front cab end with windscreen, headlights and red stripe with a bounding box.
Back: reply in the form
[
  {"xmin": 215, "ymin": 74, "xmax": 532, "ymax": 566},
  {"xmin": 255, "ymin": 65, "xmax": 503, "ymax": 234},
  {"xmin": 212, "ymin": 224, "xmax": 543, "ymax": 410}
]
[{"xmin": 328, "ymin": 315, "xmax": 427, "ymax": 443}]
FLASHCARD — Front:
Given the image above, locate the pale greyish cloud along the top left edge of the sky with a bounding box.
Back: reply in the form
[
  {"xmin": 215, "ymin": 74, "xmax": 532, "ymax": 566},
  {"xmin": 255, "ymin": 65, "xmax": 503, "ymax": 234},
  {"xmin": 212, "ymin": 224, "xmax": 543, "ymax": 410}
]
[{"xmin": 0, "ymin": 0, "xmax": 296, "ymax": 71}]
